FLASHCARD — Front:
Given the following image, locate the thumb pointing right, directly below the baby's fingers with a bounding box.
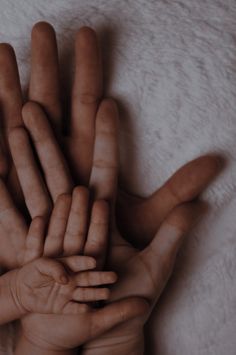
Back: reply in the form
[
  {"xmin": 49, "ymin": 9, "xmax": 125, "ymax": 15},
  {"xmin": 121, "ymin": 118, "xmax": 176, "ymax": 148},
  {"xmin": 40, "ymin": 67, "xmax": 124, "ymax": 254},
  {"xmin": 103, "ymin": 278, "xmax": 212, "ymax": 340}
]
[{"xmin": 91, "ymin": 297, "xmax": 149, "ymax": 337}]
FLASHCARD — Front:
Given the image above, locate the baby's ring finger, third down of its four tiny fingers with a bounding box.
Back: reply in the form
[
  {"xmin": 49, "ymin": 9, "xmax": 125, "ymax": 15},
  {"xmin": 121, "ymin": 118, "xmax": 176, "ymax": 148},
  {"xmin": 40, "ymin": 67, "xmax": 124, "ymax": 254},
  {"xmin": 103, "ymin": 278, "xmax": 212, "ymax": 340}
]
[{"xmin": 73, "ymin": 287, "xmax": 110, "ymax": 302}]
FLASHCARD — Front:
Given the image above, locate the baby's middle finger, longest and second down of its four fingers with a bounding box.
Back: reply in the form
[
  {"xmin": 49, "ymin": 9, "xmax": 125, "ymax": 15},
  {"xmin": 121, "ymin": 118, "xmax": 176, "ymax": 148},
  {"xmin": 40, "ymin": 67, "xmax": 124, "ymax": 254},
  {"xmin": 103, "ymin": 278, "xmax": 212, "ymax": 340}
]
[{"xmin": 74, "ymin": 271, "xmax": 117, "ymax": 287}]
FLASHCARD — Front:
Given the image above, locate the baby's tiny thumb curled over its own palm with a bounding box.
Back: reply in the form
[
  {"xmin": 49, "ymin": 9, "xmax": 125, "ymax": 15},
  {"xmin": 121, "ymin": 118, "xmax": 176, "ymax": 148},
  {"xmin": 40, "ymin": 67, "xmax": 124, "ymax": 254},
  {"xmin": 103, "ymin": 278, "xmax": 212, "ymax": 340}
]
[{"xmin": 37, "ymin": 258, "xmax": 69, "ymax": 285}]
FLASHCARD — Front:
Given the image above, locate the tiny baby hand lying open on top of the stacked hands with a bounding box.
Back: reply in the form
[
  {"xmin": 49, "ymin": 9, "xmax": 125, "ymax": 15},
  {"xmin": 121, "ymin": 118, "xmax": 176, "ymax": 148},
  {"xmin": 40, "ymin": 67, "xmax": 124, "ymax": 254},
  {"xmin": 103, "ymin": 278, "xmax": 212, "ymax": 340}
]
[{"xmin": 11, "ymin": 256, "xmax": 116, "ymax": 314}]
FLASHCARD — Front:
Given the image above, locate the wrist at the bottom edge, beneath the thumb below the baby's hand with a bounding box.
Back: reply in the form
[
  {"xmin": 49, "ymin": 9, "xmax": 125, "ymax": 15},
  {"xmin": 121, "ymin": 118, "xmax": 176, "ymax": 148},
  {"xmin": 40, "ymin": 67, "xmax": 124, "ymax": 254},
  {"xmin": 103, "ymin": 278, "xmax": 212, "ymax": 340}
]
[{"xmin": 82, "ymin": 331, "xmax": 144, "ymax": 355}]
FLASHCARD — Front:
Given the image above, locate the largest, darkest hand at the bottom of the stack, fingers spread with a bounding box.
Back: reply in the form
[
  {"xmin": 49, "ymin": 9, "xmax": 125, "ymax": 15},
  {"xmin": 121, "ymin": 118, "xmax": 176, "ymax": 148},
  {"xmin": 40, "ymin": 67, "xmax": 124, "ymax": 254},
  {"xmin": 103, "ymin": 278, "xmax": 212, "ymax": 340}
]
[{"xmin": 0, "ymin": 22, "xmax": 219, "ymax": 256}]
